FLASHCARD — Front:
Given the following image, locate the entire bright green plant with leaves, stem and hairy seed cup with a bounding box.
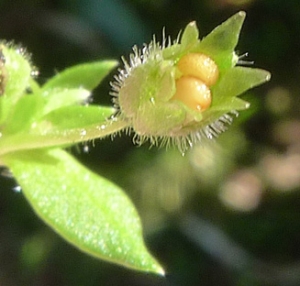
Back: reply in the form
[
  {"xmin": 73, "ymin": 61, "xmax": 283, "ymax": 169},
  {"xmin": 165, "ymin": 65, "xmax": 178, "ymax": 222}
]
[{"xmin": 0, "ymin": 12, "xmax": 270, "ymax": 274}]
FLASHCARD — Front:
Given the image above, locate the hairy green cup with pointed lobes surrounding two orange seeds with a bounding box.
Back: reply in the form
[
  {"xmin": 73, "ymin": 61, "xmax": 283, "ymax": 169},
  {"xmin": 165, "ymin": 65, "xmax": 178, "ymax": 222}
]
[{"xmin": 112, "ymin": 12, "xmax": 270, "ymax": 151}]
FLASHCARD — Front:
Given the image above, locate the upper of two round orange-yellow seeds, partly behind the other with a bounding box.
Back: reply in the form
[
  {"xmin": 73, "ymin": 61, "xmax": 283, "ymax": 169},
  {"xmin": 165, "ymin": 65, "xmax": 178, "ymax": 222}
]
[{"xmin": 177, "ymin": 53, "xmax": 219, "ymax": 86}]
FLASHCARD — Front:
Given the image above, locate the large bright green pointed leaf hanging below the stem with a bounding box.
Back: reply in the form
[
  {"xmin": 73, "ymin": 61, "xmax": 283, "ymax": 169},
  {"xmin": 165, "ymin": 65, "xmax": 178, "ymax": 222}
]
[{"xmin": 2, "ymin": 149, "xmax": 164, "ymax": 274}]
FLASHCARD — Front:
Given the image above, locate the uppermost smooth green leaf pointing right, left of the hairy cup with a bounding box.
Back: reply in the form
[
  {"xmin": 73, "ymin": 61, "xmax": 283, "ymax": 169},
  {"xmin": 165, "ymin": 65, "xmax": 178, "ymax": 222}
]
[{"xmin": 42, "ymin": 61, "xmax": 117, "ymax": 91}]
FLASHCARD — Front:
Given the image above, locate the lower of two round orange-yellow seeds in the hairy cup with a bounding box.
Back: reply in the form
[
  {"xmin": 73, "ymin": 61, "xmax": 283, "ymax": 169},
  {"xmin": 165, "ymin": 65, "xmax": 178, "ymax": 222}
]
[{"xmin": 172, "ymin": 76, "xmax": 211, "ymax": 111}]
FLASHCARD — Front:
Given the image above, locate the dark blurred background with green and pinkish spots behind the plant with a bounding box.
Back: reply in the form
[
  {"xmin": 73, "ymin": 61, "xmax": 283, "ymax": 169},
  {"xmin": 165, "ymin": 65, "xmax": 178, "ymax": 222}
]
[{"xmin": 0, "ymin": 0, "xmax": 300, "ymax": 286}]
